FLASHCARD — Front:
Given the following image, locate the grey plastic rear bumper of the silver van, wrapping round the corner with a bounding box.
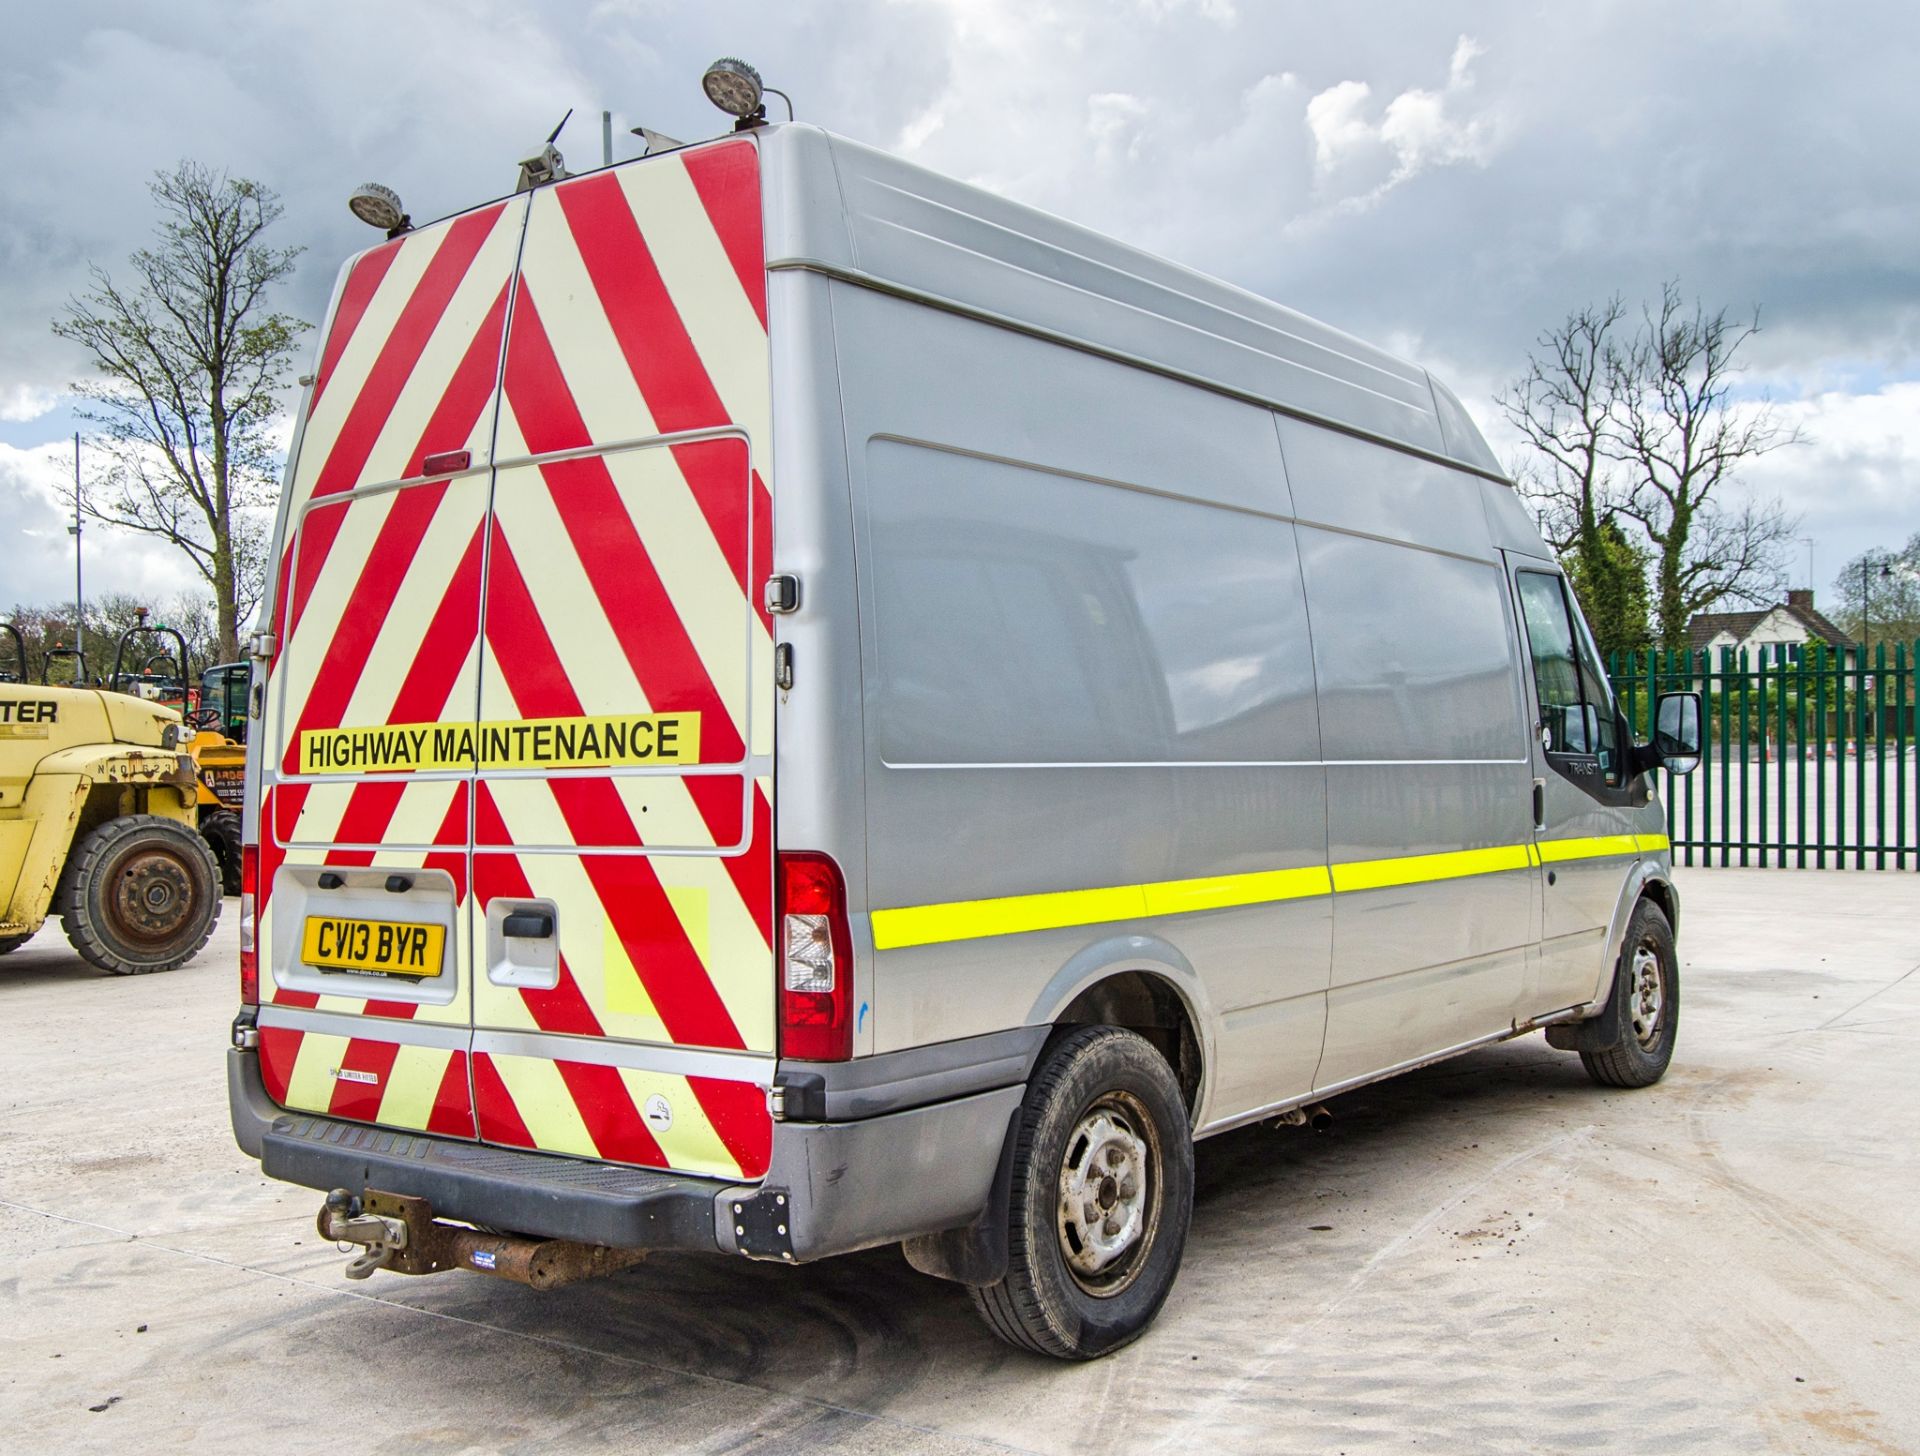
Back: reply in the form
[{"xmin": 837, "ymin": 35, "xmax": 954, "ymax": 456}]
[{"xmin": 227, "ymin": 1028, "xmax": 1048, "ymax": 1262}]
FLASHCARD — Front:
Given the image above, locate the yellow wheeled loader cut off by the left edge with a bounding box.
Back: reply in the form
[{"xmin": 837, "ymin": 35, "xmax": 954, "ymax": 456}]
[{"xmin": 0, "ymin": 624, "xmax": 221, "ymax": 976}]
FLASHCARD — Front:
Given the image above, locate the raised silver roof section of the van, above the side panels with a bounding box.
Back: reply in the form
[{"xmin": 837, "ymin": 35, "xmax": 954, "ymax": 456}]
[{"xmin": 758, "ymin": 123, "xmax": 1505, "ymax": 480}]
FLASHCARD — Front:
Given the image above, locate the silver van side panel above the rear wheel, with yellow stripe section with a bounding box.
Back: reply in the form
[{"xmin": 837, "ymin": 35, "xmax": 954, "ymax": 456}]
[{"xmin": 833, "ymin": 286, "xmax": 1329, "ymax": 1116}]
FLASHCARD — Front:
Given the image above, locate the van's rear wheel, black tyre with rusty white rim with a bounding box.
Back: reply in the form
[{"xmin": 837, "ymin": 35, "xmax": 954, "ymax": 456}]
[{"xmin": 972, "ymin": 1026, "xmax": 1194, "ymax": 1360}]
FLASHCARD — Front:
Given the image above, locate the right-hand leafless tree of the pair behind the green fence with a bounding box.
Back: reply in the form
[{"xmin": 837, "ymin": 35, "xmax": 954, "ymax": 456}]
[{"xmin": 1611, "ymin": 282, "xmax": 1801, "ymax": 647}]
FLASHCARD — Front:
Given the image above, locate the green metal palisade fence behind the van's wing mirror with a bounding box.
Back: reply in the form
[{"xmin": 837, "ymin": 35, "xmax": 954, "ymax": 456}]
[{"xmin": 1607, "ymin": 642, "xmax": 1920, "ymax": 870}]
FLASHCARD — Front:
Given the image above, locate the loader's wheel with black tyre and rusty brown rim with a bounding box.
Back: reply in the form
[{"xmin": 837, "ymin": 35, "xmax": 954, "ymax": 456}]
[{"xmin": 60, "ymin": 814, "xmax": 221, "ymax": 976}]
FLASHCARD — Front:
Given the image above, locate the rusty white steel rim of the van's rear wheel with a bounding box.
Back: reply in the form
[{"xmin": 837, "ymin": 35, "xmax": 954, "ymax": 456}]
[{"xmin": 1056, "ymin": 1091, "xmax": 1160, "ymax": 1298}]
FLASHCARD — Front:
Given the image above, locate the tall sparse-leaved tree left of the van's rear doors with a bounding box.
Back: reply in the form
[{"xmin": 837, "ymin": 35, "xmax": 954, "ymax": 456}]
[{"xmin": 54, "ymin": 161, "xmax": 307, "ymax": 659}]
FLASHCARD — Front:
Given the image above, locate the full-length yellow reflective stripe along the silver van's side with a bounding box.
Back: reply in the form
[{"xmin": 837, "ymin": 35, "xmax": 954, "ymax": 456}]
[{"xmin": 872, "ymin": 834, "xmax": 1668, "ymax": 951}]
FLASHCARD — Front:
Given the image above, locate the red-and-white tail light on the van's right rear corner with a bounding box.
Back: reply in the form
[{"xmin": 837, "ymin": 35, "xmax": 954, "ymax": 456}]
[{"xmin": 780, "ymin": 853, "xmax": 852, "ymax": 1062}]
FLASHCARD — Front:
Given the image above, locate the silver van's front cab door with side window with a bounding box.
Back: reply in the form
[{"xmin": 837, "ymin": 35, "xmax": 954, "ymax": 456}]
[{"xmin": 1509, "ymin": 555, "xmax": 1645, "ymax": 1014}]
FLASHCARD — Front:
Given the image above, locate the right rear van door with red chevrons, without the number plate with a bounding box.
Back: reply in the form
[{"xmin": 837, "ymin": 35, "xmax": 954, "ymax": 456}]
[{"xmin": 472, "ymin": 140, "xmax": 774, "ymax": 1177}]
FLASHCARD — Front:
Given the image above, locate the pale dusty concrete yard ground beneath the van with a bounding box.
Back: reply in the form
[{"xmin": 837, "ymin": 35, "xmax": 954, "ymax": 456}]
[{"xmin": 0, "ymin": 870, "xmax": 1920, "ymax": 1452}]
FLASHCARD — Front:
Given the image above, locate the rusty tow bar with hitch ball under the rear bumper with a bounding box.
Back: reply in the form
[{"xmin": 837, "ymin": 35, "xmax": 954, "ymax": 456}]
[{"xmin": 315, "ymin": 1189, "xmax": 647, "ymax": 1289}]
